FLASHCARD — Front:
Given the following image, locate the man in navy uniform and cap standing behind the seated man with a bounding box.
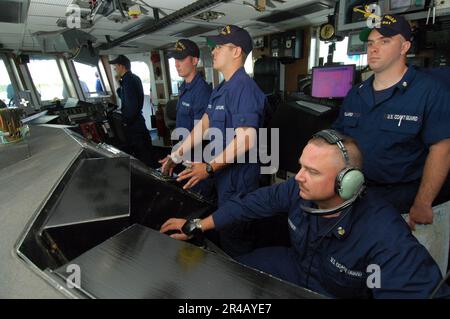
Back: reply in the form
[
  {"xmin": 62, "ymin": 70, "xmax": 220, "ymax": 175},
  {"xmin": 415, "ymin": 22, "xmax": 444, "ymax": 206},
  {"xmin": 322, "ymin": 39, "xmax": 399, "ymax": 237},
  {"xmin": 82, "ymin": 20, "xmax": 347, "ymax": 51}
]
[{"xmin": 333, "ymin": 15, "xmax": 450, "ymax": 229}]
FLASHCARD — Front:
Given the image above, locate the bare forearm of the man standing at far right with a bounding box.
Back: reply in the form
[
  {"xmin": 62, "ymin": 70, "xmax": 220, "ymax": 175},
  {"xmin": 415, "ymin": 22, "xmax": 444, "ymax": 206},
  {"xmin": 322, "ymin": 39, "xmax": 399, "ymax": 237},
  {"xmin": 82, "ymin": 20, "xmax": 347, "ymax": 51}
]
[{"xmin": 414, "ymin": 139, "xmax": 450, "ymax": 206}]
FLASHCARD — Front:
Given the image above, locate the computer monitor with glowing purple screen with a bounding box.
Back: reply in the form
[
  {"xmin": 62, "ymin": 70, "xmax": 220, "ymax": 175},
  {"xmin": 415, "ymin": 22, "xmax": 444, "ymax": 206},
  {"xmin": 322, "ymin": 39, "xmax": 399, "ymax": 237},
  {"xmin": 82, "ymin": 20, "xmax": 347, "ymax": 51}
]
[{"xmin": 311, "ymin": 64, "xmax": 355, "ymax": 98}]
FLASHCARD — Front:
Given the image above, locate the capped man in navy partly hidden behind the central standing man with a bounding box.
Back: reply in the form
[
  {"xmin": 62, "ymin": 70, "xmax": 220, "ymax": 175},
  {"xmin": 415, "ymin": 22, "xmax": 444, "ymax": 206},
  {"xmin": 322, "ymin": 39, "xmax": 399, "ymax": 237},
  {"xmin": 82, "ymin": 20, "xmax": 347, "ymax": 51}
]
[{"xmin": 168, "ymin": 39, "xmax": 211, "ymax": 132}]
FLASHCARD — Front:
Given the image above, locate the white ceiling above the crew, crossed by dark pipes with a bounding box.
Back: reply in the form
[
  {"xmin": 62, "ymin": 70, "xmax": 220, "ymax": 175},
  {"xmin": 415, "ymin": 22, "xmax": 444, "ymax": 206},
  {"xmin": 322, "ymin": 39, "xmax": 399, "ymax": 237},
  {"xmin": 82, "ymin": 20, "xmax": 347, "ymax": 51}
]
[{"xmin": 0, "ymin": 0, "xmax": 331, "ymax": 53}]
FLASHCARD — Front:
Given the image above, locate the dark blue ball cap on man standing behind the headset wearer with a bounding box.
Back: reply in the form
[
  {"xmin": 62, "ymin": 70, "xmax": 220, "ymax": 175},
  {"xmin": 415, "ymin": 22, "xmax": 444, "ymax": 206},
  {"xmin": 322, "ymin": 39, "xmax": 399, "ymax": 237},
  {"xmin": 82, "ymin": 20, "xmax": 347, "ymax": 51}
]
[{"xmin": 359, "ymin": 14, "xmax": 412, "ymax": 42}]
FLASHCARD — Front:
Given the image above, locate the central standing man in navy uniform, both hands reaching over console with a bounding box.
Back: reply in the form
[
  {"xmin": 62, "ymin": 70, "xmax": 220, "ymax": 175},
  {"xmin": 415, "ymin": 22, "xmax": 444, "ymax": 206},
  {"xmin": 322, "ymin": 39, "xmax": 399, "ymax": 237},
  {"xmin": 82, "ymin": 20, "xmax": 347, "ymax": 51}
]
[{"xmin": 163, "ymin": 25, "xmax": 266, "ymax": 256}]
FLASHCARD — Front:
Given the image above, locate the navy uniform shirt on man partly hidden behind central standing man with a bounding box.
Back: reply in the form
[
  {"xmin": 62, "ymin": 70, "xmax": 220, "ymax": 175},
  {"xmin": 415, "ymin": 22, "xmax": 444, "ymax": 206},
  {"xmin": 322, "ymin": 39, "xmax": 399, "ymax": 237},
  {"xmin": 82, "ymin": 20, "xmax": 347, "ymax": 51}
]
[{"xmin": 176, "ymin": 73, "xmax": 211, "ymax": 132}]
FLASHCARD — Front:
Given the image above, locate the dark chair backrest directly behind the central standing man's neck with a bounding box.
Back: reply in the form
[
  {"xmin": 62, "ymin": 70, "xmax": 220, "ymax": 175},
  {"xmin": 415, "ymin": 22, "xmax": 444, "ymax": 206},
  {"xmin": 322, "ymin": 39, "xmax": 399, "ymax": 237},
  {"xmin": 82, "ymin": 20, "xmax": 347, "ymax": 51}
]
[{"xmin": 253, "ymin": 57, "xmax": 280, "ymax": 95}]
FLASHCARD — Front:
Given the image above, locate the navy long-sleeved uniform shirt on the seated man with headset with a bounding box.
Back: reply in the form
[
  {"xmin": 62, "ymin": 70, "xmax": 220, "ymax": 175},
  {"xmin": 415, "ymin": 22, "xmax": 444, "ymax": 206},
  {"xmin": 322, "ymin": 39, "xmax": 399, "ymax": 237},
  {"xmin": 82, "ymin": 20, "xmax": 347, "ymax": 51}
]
[{"xmin": 213, "ymin": 178, "xmax": 450, "ymax": 298}]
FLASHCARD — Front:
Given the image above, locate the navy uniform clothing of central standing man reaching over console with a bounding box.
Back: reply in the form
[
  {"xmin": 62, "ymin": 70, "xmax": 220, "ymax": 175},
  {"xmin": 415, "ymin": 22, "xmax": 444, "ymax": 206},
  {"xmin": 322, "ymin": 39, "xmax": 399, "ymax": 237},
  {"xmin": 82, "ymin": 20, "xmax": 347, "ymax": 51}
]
[{"xmin": 206, "ymin": 67, "xmax": 266, "ymax": 206}]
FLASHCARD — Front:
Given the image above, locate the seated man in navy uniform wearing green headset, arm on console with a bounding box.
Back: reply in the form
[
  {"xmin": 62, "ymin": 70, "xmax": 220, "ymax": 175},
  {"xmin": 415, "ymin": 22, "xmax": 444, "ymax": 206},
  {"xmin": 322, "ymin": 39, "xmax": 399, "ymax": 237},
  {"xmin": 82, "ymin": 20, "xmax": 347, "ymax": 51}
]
[{"xmin": 161, "ymin": 130, "xmax": 450, "ymax": 298}]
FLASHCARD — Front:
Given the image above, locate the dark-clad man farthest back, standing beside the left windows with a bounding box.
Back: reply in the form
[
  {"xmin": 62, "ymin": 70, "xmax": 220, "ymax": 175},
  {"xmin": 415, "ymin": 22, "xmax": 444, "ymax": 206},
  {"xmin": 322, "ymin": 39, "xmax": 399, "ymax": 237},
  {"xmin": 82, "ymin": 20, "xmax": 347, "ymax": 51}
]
[{"xmin": 109, "ymin": 55, "xmax": 157, "ymax": 167}]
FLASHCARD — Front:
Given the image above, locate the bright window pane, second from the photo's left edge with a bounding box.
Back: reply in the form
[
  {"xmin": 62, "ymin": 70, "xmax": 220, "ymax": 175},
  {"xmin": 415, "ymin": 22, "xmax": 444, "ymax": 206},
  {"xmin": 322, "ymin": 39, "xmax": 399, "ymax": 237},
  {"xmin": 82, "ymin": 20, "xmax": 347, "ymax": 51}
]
[{"xmin": 28, "ymin": 57, "xmax": 68, "ymax": 101}]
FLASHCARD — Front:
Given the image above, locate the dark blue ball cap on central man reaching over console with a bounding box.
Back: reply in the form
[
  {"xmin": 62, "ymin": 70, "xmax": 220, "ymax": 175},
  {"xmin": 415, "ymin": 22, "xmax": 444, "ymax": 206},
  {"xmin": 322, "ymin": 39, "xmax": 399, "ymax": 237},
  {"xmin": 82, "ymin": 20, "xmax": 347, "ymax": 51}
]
[{"xmin": 206, "ymin": 25, "xmax": 253, "ymax": 54}]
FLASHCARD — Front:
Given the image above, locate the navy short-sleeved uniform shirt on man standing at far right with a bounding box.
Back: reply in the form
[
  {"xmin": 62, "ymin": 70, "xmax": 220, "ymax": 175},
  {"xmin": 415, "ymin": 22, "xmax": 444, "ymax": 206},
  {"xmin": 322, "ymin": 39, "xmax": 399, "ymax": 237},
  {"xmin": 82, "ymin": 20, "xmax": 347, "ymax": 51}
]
[{"xmin": 333, "ymin": 67, "xmax": 450, "ymax": 188}]
